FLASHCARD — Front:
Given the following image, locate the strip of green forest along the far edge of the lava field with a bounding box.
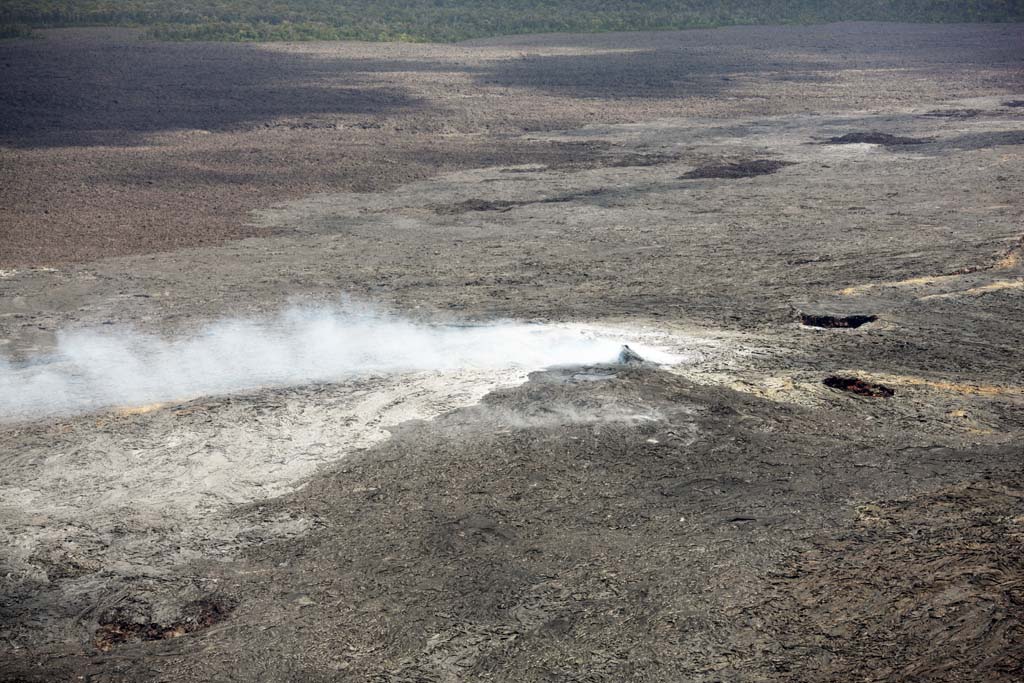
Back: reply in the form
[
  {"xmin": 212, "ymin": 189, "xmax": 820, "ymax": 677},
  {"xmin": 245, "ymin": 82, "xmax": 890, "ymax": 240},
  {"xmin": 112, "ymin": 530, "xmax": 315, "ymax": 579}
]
[{"xmin": 0, "ymin": 0, "xmax": 1024, "ymax": 42}]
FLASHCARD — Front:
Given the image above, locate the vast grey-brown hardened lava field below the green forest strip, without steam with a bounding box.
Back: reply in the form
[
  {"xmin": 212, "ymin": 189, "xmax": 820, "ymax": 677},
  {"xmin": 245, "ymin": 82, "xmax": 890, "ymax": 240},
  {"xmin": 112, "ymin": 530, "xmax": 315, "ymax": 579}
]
[{"xmin": 0, "ymin": 25, "xmax": 1024, "ymax": 682}]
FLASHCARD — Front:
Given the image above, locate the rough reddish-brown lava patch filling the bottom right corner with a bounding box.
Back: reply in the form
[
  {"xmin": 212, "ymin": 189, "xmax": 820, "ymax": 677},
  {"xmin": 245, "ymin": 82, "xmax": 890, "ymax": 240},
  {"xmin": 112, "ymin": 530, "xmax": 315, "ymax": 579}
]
[{"xmin": 773, "ymin": 480, "xmax": 1024, "ymax": 683}]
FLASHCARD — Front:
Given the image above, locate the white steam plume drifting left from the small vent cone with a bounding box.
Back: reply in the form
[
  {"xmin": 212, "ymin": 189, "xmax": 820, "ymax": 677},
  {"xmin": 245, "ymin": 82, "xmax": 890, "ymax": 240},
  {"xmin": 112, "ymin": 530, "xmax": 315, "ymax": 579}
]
[{"xmin": 0, "ymin": 308, "xmax": 667, "ymax": 422}]
